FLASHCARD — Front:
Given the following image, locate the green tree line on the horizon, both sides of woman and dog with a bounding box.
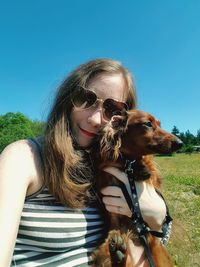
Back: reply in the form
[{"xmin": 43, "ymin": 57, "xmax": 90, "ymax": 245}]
[{"xmin": 0, "ymin": 112, "xmax": 200, "ymax": 153}]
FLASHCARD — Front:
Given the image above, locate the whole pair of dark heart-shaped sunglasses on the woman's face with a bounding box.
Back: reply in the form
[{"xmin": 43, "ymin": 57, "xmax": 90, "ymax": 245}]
[{"xmin": 71, "ymin": 86, "xmax": 128, "ymax": 120}]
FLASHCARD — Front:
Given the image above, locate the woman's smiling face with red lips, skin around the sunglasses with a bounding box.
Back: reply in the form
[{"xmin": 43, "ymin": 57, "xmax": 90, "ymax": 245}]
[{"xmin": 71, "ymin": 74, "xmax": 126, "ymax": 148}]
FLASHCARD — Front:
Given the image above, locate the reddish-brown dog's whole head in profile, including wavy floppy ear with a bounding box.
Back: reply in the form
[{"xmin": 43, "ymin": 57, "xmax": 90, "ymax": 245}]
[{"xmin": 101, "ymin": 110, "xmax": 183, "ymax": 159}]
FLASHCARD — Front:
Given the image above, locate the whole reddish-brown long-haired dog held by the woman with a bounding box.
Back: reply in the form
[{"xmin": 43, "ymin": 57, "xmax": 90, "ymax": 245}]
[{"xmin": 94, "ymin": 110, "xmax": 182, "ymax": 267}]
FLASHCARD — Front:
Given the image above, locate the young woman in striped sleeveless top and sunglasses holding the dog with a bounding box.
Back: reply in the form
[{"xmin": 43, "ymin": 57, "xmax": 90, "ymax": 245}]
[{"xmin": 0, "ymin": 59, "xmax": 166, "ymax": 267}]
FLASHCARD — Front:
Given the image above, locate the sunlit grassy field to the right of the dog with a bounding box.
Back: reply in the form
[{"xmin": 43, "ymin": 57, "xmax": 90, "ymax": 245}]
[{"xmin": 155, "ymin": 154, "xmax": 200, "ymax": 267}]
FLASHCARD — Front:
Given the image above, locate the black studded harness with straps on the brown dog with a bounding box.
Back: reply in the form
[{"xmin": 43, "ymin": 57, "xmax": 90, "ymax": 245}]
[{"xmin": 121, "ymin": 160, "xmax": 172, "ymax": 267}]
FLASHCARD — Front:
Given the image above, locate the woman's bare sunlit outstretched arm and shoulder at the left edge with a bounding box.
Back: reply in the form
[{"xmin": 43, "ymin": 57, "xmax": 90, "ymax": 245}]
[{"xmin": 0, "ymin": 140, "xmax": 39, "ymax": 267}]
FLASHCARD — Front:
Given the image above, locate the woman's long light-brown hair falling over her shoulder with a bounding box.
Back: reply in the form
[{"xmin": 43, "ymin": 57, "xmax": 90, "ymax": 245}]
[{"xmin": 44, "ymin": 59, "xmax": 136, "ymax": 208}]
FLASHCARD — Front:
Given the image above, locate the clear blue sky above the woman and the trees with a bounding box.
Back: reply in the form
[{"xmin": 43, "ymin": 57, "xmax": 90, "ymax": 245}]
[{"xmin": 0, "ymin": 0, "xmax": 200, "ymax": 135}]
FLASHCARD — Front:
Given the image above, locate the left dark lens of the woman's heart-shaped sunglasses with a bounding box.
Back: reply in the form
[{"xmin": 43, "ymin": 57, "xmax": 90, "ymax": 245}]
[{"xmin": 72, "ymin": 87, "xmax": 97, "ymax": 109}]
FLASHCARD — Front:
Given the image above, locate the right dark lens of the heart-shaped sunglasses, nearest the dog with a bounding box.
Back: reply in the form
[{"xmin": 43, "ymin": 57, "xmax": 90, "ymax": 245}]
[{"xmin": 103, "ymin": 98, "xmax": 127, "ymax": 120}]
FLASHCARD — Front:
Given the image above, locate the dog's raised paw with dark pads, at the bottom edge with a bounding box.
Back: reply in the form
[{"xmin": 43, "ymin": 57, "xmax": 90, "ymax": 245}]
[{"xmin": 109, "ymin": 231, "xmax": 127, "ymax": 266}]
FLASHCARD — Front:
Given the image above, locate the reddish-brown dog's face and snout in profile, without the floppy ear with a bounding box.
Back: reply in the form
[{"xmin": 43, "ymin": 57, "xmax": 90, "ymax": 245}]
[{"xmin": 120, "ymin": 110, "xmax": 183, "ymax": 157}]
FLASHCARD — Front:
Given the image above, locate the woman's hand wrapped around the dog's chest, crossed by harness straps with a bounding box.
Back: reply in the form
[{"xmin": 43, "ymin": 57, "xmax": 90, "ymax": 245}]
[{"xmin": 101, "ymin": 167, "xmax": 166, "ymax": 231}]
